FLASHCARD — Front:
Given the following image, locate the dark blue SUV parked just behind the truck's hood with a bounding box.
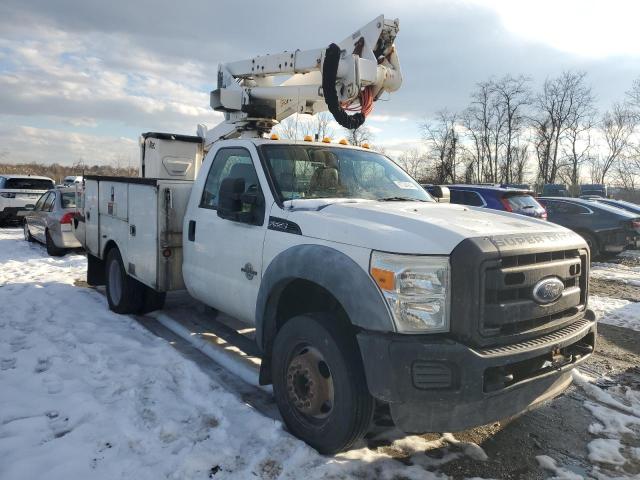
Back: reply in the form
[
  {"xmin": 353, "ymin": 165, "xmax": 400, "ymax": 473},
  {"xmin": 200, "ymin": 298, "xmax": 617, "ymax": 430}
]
[{"xmin": 448, "ymin": 185, "xmax": 547, "ymax": 219}]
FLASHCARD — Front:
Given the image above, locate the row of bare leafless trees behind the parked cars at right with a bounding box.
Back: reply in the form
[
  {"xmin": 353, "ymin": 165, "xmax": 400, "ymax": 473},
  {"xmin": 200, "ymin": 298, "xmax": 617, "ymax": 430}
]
[{"xmin": 397, "ymin": 71, "xmax": 640, "ymax": 191}]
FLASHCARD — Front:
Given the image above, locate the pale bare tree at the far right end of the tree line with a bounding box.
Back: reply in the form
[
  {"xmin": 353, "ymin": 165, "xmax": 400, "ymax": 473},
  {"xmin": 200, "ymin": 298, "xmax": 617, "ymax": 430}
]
[{"xmin": 596, "ymin": 103, "xmax": 636, "ymax": 183}]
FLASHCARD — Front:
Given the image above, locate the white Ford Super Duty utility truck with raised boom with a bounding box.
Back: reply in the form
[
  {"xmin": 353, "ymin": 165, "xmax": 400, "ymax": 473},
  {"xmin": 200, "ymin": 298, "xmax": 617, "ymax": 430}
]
[{"xmin": 76, "ymin": 16, "xmax": 596, "ymax": 453}]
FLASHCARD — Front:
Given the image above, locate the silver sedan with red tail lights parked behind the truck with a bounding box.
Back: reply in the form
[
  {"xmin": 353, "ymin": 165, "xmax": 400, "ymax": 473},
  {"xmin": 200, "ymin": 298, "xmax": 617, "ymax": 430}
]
[{"xmin": 24, "ymin": 188, "xmax": 81, "ymax": 257}]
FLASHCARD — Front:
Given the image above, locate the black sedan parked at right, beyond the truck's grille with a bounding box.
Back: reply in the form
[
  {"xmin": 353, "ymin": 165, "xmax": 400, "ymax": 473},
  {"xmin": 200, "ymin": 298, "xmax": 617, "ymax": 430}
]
[{"xmin": 538, "ymin": 197, "xmax": 640, "ymax": 259}]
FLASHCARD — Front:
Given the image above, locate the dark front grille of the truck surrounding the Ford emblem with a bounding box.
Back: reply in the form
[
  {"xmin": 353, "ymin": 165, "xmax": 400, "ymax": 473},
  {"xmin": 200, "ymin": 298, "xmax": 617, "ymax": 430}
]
[{"xmin": 480, "ymin": 249, "xmax": 589, "ymax": 340}]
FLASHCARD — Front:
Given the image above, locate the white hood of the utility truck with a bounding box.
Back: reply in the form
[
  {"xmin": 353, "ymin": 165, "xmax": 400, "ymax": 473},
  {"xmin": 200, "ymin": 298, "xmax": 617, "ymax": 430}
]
[{"xmin": 286, "ymin": 200, "xmax": 569, "ymax": 255}]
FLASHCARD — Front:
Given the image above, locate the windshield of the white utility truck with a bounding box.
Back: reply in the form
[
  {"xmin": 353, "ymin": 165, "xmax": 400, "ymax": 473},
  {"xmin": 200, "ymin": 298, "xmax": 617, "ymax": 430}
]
[{"xmin": 262, "ymin": 144, "xmax": 433, "ymax": 202}]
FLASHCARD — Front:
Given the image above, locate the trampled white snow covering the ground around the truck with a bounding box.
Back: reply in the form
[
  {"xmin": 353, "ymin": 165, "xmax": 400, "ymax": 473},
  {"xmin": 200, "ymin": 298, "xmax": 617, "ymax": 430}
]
[{"xmin": 0, "ymin": 229, "xmax": 640, "ymax": 480}]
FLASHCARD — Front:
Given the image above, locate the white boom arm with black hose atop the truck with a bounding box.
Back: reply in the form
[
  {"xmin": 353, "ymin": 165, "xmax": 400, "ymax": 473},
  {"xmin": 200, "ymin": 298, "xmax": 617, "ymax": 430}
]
[{"xmin": 205, "ymin": 15, "xmax": 402, "ymax": 147}]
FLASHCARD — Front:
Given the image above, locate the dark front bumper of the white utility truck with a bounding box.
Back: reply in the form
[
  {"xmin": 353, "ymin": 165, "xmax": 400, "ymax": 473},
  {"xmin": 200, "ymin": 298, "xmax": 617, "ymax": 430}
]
[{"xmin": 358, "ymin": 310, "xmax": 596, "ymax": 433}]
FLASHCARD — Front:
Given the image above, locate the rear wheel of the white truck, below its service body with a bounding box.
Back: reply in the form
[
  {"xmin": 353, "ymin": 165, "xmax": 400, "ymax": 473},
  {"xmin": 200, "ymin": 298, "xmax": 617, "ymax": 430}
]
[{"xmin": 105, "ymin": 248, "xmax": 144, "ymax": 314}]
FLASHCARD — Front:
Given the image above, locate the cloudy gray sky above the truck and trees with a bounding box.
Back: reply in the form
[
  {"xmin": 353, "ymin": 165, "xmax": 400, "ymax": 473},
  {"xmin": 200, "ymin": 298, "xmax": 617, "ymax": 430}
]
[{"xmin": 0, "ymin": 0, "xmax": 640, "ymax": 164}]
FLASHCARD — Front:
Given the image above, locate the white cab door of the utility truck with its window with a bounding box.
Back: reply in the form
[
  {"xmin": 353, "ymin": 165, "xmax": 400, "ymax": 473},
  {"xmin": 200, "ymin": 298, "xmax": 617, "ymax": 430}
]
[{"xmin": 183, "ymin": 147, "xmax": 270, "ymax": 323}]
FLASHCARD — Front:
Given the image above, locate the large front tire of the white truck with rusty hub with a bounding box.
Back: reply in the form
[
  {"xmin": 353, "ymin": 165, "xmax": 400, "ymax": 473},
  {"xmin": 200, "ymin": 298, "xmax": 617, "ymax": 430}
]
[{"xmin": 272, "ymin": 313, "xmax": 375, "ymax": 454}]
